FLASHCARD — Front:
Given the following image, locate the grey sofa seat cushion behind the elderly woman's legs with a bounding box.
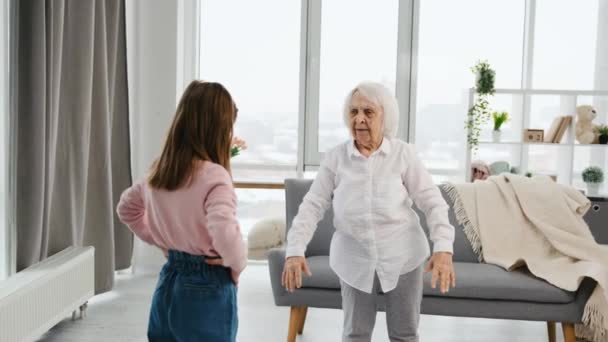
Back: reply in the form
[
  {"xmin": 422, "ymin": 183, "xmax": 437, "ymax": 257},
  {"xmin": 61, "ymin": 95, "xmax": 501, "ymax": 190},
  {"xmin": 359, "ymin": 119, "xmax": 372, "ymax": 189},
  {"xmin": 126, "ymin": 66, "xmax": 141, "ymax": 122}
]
[{"xmin": 302, "ymin": 256, "xmax": 575, "ymax": 303}]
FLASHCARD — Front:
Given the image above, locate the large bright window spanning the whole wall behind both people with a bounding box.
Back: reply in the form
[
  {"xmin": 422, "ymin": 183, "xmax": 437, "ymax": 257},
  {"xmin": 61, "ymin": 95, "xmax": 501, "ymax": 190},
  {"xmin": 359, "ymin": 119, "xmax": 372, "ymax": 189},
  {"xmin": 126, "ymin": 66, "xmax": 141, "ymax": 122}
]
[{"xmin": 200, "ymin": 0, "xmax": 608, "ymax": 238}]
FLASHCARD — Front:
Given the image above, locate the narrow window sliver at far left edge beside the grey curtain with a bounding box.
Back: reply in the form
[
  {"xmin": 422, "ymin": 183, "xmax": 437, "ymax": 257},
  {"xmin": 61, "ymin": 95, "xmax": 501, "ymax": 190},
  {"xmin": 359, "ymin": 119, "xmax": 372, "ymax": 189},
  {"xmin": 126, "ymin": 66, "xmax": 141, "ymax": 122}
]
[{"xmin": 0, "ymin": 0, "xmax": 9, "ymax": 280}]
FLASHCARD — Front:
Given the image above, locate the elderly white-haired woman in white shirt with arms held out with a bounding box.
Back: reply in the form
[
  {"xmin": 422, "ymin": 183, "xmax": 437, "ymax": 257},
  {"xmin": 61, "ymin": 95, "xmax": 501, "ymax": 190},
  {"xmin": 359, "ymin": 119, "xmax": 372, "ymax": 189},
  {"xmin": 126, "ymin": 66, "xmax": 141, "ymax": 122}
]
[{"xmin": 282, "ymin": 83, "xmax": 456, "ymax": 342}]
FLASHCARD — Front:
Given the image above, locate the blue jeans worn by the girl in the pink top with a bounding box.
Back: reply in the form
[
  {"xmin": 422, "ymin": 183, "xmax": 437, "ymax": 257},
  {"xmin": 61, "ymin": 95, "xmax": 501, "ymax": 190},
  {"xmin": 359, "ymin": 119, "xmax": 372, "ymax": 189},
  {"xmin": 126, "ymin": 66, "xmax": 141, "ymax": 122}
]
[{"xmin": 148, "ymin": 251, "xmax": 238, "ymax": 342}]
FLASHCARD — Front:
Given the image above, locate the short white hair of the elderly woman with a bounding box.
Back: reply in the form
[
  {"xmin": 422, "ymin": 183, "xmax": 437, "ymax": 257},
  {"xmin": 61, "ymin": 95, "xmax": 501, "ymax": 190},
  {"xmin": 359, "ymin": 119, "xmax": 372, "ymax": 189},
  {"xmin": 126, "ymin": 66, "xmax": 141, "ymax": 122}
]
[{"xmin": 343, "ymin": 82, "xmax": 399, "ymax": 138}]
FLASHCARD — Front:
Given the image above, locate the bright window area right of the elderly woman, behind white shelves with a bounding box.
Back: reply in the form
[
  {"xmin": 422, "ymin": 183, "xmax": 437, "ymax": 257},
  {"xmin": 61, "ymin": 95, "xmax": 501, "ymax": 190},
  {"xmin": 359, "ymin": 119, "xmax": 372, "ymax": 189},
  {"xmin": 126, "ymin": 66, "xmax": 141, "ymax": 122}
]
[{"xmin": 412, "ymin": 0, "xmax": 608, "ymax": 181}]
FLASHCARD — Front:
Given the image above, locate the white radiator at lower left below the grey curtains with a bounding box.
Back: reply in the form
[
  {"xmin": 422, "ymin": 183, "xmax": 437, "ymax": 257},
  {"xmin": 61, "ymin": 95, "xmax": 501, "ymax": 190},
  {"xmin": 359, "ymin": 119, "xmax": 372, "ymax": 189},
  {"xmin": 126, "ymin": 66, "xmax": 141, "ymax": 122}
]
[{"xmin": 0, "ymin": 247, "xmax": 95, "ymax": 342}]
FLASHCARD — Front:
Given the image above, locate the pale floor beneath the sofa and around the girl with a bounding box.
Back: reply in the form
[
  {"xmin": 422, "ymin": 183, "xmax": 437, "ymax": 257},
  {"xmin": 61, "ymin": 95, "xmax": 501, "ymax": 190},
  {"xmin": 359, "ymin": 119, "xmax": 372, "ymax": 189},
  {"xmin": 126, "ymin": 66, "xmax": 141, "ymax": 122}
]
[{"xmin": 39, "ymin": 264, "xmax": 563, "ymax": 342}]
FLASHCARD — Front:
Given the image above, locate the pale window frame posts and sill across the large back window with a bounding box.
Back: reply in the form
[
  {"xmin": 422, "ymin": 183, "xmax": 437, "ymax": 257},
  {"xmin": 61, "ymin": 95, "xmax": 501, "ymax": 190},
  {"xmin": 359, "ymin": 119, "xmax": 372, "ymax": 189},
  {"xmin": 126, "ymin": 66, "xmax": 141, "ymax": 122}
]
[{"xmin": 193, "ymin": 0, "xmax": 604, "ymax": 178}]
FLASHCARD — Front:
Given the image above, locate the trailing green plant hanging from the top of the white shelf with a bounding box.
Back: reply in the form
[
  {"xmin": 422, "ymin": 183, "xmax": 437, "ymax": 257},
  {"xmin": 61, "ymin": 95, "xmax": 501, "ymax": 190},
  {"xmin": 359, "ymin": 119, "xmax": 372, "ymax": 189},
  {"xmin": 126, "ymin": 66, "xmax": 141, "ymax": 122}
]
[{"xmin": 465, "ymin": 61, "xmax": 496, "ymax": 150}]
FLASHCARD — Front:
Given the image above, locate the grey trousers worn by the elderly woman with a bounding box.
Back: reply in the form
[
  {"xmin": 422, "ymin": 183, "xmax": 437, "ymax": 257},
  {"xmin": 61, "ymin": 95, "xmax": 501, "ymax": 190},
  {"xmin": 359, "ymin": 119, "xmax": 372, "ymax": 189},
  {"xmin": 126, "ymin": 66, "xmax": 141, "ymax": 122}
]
[{"xmin": 340, "ymin": 265, "xmax": 424, "ymax": 342}]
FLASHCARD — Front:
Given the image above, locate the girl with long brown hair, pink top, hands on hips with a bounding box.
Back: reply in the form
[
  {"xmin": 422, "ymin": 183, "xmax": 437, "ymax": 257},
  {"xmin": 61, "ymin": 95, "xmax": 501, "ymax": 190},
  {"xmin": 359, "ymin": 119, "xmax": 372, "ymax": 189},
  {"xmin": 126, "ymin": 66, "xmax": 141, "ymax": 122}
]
[{"xmin": 117, "ymin": 81, "xmax": 247, "ymax": 342}]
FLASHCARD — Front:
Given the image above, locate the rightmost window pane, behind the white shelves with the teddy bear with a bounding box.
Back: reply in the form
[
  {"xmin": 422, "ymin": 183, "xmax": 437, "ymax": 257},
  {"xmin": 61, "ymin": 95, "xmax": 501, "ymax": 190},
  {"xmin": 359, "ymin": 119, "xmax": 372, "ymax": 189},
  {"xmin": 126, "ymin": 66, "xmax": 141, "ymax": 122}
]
[{"xmin": 529, "ymin": 0, "xmax": 608, "ymax": 186}]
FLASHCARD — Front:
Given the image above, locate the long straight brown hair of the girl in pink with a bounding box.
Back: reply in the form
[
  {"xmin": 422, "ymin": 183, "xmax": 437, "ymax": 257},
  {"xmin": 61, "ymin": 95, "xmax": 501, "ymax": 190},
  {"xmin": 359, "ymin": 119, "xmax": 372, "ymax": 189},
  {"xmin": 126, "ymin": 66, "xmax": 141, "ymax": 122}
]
[{"xmin": 148, "ymin": 81, "xmax": 236, "ymax": 190}]
